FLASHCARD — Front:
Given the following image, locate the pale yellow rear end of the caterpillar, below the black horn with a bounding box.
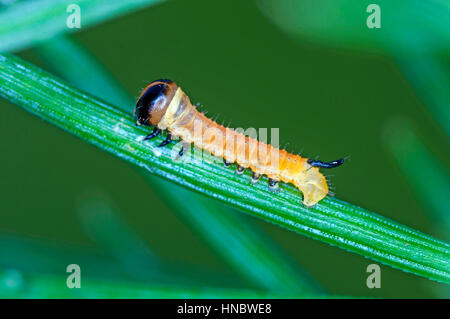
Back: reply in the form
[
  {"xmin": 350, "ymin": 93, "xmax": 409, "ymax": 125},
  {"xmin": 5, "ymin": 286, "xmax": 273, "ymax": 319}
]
[{"xmin": 294, "ymin": 167, "xmax": 328, "ymax": 206}]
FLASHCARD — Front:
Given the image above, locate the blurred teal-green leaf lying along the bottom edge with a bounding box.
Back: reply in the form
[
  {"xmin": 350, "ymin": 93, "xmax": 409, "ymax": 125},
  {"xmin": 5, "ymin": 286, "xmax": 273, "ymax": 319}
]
[{"xmin": 0, "ymin": 270, "xmax": 336, "ymax": 299}]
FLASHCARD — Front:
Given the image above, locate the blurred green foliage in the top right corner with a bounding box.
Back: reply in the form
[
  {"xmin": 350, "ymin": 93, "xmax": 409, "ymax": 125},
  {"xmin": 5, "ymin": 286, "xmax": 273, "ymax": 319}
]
[{"xmin": 258, "ymin": 0, "xmax": 450, "ymax": 54}]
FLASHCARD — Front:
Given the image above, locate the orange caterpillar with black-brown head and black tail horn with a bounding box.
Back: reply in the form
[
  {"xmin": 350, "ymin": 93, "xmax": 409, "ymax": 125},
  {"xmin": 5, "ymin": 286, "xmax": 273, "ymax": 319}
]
[{"xmin": 134, "ymin": 79, "xmax": 344, "ymax": 206}]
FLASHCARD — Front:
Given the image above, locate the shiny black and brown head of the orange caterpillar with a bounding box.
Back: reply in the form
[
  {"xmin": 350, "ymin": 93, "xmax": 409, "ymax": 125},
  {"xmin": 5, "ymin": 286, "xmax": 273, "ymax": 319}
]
[{"xmin": 134, "ymin": 79, "xmax": 178, "ymax": 126}]
